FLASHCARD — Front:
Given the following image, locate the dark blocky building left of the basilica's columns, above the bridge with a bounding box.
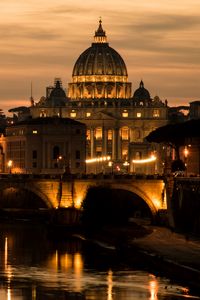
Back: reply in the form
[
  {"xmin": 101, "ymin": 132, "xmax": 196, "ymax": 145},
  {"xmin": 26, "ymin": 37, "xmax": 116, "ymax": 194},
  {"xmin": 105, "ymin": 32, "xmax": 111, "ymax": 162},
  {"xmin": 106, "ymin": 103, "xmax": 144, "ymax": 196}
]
[{"xmin": 0, "ymin": 117, "xmax": 86, "ymax": 174}]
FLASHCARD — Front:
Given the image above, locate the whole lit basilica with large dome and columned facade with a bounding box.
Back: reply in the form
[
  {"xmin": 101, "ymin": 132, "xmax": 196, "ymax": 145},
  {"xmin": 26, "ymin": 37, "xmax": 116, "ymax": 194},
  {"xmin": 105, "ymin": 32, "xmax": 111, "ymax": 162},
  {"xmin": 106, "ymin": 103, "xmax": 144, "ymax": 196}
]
[{"xmin": 3, "ymin": 20, "xmax": 168, "ymax": 173}]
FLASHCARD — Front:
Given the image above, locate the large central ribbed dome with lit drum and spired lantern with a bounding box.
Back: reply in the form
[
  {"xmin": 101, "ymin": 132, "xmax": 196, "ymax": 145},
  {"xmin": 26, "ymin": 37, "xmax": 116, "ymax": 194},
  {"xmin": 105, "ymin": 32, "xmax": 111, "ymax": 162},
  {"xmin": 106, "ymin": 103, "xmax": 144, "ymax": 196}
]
[{"xmin": 68, "ymin": 20, "xmax": 131, "ymax": 99}]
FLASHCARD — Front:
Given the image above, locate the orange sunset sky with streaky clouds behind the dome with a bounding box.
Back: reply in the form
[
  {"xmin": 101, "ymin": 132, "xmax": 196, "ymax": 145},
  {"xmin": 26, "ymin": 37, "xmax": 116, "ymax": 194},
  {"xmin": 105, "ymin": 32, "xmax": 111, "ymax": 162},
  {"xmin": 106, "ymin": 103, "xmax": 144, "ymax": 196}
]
[{"xmin": 0, "ymin": 0, "xmax": 200, "ymax": 112}]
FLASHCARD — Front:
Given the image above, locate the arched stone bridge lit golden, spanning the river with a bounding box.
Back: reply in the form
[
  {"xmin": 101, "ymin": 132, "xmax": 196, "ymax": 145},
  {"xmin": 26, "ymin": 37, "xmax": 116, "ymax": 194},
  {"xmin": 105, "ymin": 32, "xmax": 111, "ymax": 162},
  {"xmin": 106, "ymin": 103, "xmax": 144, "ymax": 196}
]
[{"xmin": 0, "ymin": 174, "xmax": 167, "ymax": 216}]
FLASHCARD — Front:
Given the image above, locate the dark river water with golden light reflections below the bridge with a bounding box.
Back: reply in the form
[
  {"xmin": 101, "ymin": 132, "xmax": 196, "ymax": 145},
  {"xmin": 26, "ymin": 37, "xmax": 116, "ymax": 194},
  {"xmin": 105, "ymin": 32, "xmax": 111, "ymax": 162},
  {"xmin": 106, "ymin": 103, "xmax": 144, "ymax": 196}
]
[{"xmin": 0, "ymin": 222, "xmax": 200, "ymax": 300}]
